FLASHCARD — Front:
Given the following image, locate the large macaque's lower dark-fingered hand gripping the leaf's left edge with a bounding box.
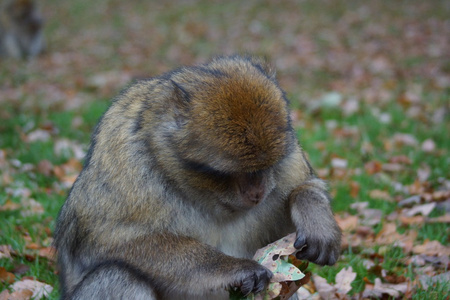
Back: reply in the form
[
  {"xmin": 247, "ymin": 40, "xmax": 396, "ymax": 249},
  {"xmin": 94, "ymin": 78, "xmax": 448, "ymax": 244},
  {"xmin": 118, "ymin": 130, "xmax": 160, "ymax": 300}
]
[{"xmin": 233, "ymin": 259, "xmax": 273, "ymax": 296}]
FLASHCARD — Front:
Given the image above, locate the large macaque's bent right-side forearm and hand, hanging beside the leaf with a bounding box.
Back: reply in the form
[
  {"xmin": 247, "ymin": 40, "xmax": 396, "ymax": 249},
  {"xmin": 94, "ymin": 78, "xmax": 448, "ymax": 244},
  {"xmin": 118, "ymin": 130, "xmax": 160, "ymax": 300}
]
[{"xmin": 289, "ymin": 179, "xmax": 341, "ymax": 265}]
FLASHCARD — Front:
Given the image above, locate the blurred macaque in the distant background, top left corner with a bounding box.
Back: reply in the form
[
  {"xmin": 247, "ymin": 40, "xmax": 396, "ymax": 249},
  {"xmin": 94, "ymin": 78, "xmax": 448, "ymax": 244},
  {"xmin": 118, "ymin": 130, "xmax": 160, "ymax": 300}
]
[{"xmin": 0, "ymin": 0, "xmax": 44, "ymax": 59}]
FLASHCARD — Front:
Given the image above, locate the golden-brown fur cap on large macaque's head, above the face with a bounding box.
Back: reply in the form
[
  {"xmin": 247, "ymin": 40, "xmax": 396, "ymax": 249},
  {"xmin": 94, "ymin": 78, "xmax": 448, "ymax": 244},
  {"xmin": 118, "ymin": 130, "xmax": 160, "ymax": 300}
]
[{"xmin": 173, "ymin": 57, "xmax": 292, "ymax": 173}]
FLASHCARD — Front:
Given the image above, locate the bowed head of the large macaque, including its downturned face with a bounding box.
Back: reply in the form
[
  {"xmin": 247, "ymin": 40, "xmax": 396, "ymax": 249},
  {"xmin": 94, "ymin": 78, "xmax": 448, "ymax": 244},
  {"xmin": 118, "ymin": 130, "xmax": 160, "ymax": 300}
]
[{"xmin": 167, "ymin": 57, "xmax": 294, "ymax": 209}]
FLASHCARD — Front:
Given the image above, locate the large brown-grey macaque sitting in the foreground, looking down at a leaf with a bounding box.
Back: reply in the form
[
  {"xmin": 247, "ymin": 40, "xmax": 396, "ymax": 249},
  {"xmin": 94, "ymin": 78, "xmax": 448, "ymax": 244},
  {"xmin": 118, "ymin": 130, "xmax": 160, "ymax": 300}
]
[{"xmin": 55, "ymin": 56, "xmax": 341, "ymax": 299}]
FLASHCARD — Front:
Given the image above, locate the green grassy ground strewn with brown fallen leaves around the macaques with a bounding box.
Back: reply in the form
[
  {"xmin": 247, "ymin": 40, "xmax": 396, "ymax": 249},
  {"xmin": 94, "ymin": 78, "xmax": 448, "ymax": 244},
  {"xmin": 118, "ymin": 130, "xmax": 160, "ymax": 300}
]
[{"xmin": 0, "ymin": 0, "xmax": 450, "ymax": 299}]
